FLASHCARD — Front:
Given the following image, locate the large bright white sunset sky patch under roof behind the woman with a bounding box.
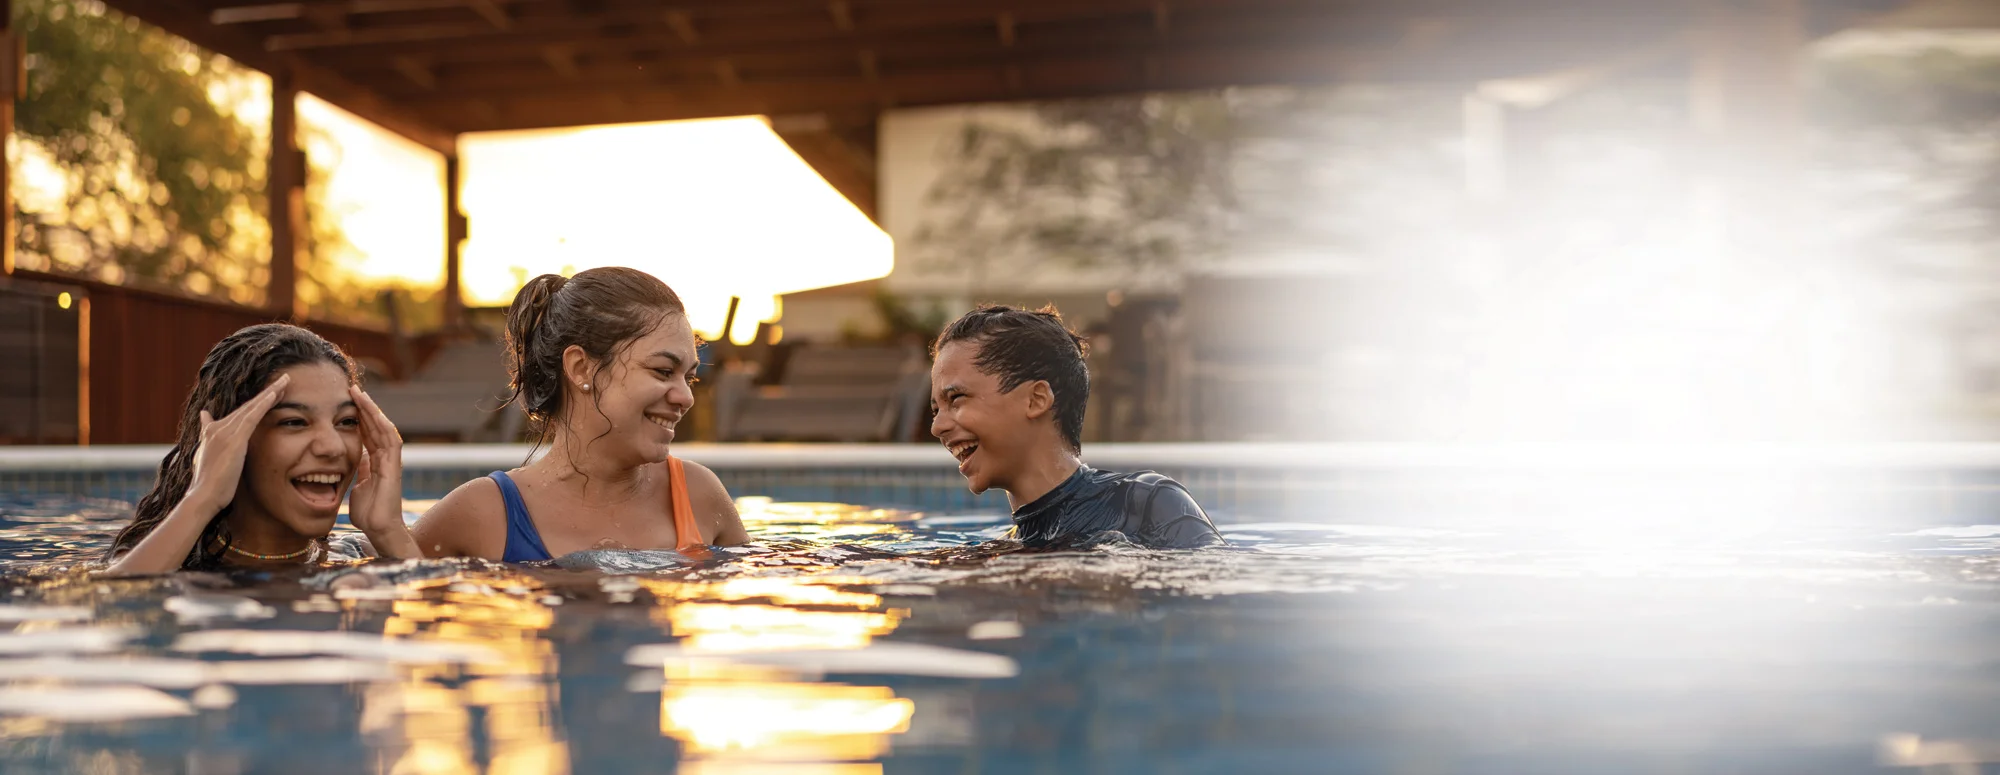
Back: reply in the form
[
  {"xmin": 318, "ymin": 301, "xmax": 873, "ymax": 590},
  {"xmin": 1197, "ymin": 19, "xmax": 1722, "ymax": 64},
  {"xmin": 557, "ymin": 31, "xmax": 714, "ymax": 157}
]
[{"xmin": 460, "ymin": 118, "xmax": 892, "ymax": 340}]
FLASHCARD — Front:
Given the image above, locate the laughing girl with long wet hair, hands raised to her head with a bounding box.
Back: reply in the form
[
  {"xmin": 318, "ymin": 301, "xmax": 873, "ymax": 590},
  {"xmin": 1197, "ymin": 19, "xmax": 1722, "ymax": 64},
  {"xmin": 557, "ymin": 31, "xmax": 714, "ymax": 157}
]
[{"xmin": 106, "ymin": 324, "xmax": 422, "ymax": 575}]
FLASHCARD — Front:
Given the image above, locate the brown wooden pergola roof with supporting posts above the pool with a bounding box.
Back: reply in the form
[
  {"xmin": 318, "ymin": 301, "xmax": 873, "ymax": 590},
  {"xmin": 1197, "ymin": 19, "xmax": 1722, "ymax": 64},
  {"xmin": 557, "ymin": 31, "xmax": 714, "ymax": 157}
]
[{"xmin": 0, "ymin": 0, "xmax": 1918, "ymax": 439}]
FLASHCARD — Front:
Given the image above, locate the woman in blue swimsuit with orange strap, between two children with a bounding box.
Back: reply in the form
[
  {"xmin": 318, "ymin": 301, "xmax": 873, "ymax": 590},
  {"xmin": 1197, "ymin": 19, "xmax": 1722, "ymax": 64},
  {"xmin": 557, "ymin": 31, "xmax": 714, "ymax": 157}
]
[{"xmin": 414, "ymin": 268, "xmax": 750, "ymax": 563}]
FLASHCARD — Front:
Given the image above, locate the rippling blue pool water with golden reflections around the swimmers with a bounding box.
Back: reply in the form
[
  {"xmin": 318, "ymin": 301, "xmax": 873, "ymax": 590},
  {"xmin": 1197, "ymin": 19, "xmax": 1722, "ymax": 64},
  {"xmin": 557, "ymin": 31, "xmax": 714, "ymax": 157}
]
[{"xmin": 0, "ymin": 499, "xmax": 2000, "ymax": 773}]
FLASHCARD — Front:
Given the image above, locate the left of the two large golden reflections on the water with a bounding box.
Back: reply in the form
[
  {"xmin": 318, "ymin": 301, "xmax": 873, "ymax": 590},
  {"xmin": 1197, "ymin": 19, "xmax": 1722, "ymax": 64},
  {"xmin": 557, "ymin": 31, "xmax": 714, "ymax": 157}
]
[{"xmin": 362, "ymin": 575, "xmax": 568, "ymax": 775}]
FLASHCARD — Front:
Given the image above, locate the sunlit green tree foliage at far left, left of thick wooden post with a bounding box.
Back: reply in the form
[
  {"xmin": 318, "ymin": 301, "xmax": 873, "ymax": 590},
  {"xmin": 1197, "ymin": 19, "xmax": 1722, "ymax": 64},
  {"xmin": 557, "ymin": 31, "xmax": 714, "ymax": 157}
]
[{"xmin": 14, "ymin": 0, "xmax": 270, "ymax": 302}]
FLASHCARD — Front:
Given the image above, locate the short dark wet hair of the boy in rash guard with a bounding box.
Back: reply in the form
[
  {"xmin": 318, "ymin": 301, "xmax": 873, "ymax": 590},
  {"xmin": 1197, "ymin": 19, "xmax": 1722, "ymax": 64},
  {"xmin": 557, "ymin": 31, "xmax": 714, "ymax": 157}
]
[{"xmin": 930, "ymin": 304, "xmax": 1090, "ymax": 451}]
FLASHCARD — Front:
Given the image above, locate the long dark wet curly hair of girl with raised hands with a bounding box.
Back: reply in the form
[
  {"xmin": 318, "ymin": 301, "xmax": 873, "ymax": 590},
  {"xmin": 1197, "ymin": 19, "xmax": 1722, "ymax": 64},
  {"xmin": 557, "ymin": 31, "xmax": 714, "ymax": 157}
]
[{"xmin": 108, "ymin": 324, "xmax": 358, "ymax": 569}]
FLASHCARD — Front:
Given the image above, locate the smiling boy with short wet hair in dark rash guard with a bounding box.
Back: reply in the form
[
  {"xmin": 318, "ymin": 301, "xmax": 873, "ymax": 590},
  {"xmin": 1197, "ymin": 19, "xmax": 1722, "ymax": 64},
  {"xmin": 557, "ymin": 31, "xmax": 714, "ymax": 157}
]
[{"xmin": 930, "ymin": 306, "xmax": 1222, "ymax": 549}]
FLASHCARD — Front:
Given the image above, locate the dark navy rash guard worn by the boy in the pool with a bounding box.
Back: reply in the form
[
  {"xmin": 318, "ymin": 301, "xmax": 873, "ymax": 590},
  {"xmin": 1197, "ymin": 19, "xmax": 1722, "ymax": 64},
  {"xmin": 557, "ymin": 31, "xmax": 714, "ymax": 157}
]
[{"xmin": 1014, "ymin": 465, "xmax": 1222, "ymax": 549}]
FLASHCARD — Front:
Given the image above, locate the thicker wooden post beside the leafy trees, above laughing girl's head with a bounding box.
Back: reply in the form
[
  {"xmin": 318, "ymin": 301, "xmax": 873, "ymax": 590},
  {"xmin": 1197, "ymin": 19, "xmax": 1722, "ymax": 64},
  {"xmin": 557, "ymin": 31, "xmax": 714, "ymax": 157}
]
[{"xmin": 264, "ymin": 68, "xmax": 306, "ymax": 320}]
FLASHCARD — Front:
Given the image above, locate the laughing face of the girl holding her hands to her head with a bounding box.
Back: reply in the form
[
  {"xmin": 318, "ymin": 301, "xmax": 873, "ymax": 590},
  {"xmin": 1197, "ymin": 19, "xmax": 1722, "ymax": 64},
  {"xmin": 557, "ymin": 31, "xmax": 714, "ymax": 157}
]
[{"xmin": 232, "ymin": 362, "xmax": 362, "ymax": 537}]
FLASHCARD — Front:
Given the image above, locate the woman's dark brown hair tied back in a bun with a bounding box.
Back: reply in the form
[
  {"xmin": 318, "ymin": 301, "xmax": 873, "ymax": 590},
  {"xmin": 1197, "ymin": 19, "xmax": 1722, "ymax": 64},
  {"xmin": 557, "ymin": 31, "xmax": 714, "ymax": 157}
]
[{"xmin": 506, "ymin": 266, "xmax": 688, "ymax": 447}]
